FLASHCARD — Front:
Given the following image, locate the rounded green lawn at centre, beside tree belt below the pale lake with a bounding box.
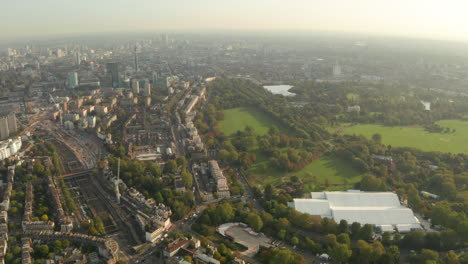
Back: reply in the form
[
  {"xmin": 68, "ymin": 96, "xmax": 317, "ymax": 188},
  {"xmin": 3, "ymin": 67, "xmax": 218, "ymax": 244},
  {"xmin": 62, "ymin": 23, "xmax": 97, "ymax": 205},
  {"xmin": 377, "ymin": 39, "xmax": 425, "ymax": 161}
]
[{"xmin": 220, "ymin": 107, "xmax": 290, "ymax": 136}]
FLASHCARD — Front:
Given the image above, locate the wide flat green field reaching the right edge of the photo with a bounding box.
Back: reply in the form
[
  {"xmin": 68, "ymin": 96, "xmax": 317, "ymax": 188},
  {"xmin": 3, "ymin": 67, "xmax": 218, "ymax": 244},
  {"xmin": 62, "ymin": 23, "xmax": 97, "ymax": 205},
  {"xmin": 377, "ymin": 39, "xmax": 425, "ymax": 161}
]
[{"xmin": 343, "ymin": 120, "xmax": 468, "ymax": 154}]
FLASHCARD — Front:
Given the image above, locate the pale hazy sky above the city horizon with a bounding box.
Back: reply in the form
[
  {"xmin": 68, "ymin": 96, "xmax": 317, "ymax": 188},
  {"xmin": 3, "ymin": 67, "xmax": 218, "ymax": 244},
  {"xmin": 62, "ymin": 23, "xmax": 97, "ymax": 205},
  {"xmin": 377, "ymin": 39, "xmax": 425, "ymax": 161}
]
[{"xmin": 0, "ymin": 0, "xmax": 468, "ymax": 40}]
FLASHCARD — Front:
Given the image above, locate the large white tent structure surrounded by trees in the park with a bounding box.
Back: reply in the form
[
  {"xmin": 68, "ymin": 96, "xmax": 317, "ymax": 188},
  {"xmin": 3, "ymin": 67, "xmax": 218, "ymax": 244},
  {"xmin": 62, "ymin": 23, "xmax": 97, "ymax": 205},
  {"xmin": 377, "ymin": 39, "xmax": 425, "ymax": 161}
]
[{"xmin": 289, "ymin": 190, "xmax": 421, "ymax": 233}]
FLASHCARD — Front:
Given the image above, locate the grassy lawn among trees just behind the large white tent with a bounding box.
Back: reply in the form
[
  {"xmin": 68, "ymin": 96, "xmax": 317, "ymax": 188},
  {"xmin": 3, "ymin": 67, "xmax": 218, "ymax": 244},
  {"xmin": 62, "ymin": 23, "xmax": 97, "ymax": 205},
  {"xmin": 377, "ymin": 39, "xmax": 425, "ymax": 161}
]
[{"xmin": 248, "ymin": 153, "xmax": 362, "ymax": 190}]
